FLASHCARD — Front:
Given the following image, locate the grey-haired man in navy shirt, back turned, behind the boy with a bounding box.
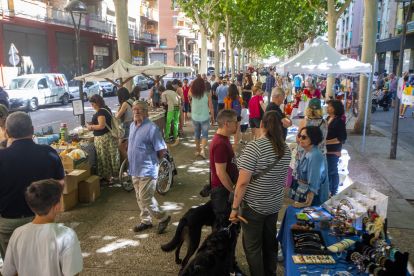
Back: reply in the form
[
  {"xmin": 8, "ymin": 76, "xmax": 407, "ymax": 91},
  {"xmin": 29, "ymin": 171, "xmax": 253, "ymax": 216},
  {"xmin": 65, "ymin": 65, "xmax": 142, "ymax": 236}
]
[{"xmin": 0, "ymin": 112, "xmax": 65, "ymax": 260}]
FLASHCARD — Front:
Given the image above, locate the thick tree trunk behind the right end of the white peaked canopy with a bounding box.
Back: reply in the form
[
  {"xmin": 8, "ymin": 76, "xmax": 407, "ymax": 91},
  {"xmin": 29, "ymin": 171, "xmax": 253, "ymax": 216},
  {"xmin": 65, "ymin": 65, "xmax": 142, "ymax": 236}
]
[{"xmin": 354, "ymin": 0, "xmax": 378, "ymax": 134}]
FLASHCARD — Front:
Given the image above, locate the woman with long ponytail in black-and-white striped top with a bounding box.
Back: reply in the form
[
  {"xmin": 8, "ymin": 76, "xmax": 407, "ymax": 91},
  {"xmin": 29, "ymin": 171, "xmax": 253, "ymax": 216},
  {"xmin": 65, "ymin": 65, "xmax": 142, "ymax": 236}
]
[{"xmin": 230, "ymin": 110, "xmax": 291, "ymax": 275}]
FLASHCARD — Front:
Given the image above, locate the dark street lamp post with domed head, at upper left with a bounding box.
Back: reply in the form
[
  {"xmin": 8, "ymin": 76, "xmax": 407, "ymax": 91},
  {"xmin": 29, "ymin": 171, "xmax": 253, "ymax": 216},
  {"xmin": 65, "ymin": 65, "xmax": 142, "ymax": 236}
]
[{"xmin": 65, "ymin": 0, "xmax": 87, "ymax": 126}]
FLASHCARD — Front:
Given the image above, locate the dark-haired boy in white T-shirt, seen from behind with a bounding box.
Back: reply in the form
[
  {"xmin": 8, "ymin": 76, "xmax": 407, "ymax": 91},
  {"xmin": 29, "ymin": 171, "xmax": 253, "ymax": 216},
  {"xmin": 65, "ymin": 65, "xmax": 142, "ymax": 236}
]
[{"xmin": 1, "ymin": 179, "xmax": 83, "ymax": 276}]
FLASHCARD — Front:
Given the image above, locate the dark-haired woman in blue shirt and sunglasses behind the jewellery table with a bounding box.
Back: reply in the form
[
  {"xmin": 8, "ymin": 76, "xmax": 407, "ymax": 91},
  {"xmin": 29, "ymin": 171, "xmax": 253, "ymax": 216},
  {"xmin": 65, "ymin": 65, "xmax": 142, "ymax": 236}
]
[{"xmin": 293, "ymin": 126, "xmax": 329, "ymax": 208}]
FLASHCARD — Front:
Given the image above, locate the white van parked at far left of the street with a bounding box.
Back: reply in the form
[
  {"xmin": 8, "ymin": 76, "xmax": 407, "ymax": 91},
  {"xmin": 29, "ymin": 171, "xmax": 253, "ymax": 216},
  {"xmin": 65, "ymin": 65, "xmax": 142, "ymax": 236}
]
[{"xmin": 6, "ymin": 74, "xmax": 69, "ymax": 111}]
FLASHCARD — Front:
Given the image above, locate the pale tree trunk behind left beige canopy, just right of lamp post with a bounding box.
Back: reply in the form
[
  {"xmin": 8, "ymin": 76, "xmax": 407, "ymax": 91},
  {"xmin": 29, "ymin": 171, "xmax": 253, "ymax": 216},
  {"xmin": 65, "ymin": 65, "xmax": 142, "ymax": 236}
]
[{"xmin": 114, "ymin": 0, "xmax": 133, "ymax": 91}]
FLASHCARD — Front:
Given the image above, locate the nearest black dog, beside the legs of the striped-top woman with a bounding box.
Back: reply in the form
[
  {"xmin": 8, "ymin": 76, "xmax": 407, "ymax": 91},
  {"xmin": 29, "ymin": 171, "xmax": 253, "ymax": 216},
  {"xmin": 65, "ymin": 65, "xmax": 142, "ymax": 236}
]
[{"xmin": 178, "ymin": 217, "xmax": 241, "ymax": 276}]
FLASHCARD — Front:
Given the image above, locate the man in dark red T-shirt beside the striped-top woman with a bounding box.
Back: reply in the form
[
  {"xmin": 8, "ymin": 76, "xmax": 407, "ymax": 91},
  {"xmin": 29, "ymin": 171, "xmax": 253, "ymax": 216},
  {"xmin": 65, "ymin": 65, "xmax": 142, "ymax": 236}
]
[{"xmin": 209, "ymin": 109, "xmax": 238, "ymax": 216}]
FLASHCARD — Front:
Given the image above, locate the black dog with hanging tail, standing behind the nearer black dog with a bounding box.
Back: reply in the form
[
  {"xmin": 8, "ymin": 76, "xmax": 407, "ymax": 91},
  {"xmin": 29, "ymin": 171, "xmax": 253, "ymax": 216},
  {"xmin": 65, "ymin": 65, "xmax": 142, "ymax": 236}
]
[{"xmin": 161, "ymin": 200, "xmax": 215, "ymax": 268}]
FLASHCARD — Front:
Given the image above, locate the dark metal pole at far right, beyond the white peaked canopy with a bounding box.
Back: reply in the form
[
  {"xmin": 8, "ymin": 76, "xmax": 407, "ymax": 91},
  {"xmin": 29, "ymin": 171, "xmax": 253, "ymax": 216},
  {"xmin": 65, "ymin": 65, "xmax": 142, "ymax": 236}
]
[{"xmin": 390, "ymin": 0, "xmax": 412, "ymax": 159}]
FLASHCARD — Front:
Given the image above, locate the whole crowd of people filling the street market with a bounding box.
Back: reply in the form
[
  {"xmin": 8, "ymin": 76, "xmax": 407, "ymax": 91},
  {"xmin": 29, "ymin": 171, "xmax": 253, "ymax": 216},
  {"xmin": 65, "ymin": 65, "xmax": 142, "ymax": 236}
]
[{"xmin": 0, "ymin": 65, "xmax": 346, "ymax": 275}]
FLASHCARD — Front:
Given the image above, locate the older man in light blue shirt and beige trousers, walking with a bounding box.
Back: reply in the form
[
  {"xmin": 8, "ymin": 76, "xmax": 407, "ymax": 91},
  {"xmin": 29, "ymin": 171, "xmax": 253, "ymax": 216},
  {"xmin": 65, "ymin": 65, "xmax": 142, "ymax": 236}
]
[{"xmin": 128, "ymin": 101, "xmax": 171, "ymax": 234}]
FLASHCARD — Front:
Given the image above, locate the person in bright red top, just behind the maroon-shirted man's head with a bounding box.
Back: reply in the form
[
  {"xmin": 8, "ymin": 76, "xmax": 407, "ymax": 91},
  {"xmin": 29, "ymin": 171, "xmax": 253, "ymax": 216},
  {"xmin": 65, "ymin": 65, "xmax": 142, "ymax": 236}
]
[{"xmin": 249, "ymin": 81, "xmax": 266, "ymax": 142}]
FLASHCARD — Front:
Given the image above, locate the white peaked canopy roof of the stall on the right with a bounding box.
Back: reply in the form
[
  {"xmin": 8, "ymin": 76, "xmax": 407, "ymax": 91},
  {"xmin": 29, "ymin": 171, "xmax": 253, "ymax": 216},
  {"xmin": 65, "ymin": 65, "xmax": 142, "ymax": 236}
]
[{"xmin": 276, "ymin": 38, "xmax": 372, "ymax": 75}]
